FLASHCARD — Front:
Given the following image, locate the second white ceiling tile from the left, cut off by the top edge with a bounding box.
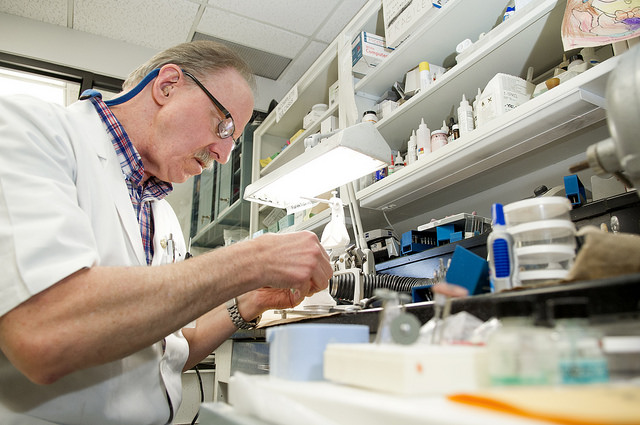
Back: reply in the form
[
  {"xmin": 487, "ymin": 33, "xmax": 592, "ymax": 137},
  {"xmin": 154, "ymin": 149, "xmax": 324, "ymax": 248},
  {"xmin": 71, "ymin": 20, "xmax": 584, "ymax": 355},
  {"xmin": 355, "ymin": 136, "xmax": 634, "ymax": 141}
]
[{"xmin": 73, "ymin": 0, "xmax": 199, "ymax": 50}]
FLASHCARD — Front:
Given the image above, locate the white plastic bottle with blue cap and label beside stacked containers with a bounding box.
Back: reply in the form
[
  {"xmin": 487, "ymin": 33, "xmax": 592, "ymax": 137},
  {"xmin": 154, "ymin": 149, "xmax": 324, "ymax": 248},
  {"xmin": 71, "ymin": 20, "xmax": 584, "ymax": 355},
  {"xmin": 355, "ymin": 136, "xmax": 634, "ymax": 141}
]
[{"xmin": 487, "ymin": 204, "xmax": 516, "ymax": 292}]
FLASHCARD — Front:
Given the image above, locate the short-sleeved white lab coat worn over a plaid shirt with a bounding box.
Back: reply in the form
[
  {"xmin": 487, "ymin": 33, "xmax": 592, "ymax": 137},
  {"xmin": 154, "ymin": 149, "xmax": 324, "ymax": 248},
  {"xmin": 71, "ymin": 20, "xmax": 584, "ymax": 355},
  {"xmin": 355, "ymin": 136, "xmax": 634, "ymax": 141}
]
[{"xmin": 0, "ymin": 97, "xmax": 188, "ymax": 425}]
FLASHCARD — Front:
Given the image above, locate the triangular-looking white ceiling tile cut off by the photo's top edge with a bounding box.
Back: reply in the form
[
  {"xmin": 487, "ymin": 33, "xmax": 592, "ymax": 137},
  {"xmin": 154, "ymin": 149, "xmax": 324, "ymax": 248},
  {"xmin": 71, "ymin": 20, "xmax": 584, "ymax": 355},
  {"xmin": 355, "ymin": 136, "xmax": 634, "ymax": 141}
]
[{"xmin": 209, "ymin": 0, "xmax": 340, "ymax": 36}]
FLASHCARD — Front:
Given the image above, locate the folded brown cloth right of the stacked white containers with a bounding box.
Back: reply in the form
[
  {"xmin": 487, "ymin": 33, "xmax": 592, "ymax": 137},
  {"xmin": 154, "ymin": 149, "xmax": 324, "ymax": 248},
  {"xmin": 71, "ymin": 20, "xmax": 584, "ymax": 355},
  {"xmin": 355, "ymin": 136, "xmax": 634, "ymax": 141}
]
[{"xmin": 565, "ymin": 226, "xmax": 640, "ymax": 282}]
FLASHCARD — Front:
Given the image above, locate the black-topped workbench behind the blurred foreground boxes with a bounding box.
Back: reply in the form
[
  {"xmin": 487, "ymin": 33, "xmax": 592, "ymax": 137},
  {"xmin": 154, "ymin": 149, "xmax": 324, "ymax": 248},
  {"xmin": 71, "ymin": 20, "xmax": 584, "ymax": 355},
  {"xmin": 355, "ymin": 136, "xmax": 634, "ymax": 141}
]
[{"xmin": 214, "ymin": 274, "xmax": 640, "ymax": 401}]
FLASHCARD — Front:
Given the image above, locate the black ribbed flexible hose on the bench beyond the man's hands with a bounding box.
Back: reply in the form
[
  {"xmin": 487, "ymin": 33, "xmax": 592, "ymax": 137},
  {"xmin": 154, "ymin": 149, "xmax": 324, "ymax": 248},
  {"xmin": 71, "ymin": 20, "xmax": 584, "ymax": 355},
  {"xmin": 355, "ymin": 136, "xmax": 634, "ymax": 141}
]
[{"xmin": 329, "ymin": 273, "xmax": 433, "ymax": 302}]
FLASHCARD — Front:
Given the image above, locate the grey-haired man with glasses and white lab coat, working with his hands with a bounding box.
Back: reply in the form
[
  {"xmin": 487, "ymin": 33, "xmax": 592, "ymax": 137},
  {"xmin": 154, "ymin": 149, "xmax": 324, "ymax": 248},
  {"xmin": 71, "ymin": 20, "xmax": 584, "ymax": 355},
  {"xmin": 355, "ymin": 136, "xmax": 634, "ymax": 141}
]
[{"xmin": 0, "ymin": 42, "xmax": 331, "ymax": 425}]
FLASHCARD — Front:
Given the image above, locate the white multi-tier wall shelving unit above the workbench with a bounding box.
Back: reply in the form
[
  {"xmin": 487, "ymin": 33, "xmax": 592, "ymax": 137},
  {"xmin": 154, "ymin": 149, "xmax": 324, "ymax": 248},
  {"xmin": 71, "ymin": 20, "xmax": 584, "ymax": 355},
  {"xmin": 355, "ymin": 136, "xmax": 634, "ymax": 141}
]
[{"xmin": 251, "ymin": 0, "xmax": 619, "ymax": 238}]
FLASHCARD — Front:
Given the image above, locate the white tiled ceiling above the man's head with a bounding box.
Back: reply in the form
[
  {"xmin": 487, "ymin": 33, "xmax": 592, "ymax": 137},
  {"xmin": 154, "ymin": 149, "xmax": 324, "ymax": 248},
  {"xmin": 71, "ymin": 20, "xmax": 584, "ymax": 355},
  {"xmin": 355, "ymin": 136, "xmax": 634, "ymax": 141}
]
[{"xmin": 0, "ymin": 0, "xmax": 367, "ymax": 111}]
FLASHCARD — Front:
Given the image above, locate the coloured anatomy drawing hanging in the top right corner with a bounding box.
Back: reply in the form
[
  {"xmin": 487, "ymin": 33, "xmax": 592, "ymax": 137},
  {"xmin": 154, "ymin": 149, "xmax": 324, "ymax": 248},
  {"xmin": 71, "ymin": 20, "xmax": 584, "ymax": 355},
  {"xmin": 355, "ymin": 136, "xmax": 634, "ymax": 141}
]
[{"xmin": 562, "ymin": 0, "xmax": 640, "ymax": 50}]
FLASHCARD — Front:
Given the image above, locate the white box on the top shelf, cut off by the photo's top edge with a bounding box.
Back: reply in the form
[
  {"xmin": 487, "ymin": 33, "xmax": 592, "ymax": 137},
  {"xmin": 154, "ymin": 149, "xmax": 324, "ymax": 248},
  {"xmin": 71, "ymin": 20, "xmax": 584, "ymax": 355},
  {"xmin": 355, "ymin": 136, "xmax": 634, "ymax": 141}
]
[{"xmin": 382, "ymin": 0, "xmax": 438, "ymax": 49}]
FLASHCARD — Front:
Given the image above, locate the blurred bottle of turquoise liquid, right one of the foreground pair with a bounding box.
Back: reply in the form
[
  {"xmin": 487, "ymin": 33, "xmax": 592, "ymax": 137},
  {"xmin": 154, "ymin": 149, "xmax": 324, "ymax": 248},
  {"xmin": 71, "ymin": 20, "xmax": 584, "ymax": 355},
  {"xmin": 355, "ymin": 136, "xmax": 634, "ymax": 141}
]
[{"xmin": 547, "ymin": 297, "xmax": 609, "ymax": 385}]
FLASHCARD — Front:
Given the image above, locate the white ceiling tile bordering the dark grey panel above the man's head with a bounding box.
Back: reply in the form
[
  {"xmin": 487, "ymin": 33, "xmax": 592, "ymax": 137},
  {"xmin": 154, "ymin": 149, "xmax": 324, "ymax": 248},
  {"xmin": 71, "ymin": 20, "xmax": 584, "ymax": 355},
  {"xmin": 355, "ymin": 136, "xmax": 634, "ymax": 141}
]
[{"xmin": 197, "ymin": 7, "xmax": 307, "ymax": 58}]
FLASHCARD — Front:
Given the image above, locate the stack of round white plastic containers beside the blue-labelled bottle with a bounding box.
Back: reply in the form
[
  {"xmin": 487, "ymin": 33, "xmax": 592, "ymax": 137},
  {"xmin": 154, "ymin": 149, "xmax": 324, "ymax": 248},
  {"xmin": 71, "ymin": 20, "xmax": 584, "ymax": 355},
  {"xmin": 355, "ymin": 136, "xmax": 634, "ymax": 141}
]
[{"xmin": 504, "ymin": 196, "xmax": 576, "ymax": 285}]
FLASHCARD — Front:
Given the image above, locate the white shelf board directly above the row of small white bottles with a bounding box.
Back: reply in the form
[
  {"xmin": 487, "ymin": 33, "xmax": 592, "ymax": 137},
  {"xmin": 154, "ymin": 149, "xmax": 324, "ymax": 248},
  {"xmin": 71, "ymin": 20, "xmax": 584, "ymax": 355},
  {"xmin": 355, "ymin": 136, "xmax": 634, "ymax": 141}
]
[{"xmin": 370, "ymin": 0, "xmax": 564, "ymax": 150}]
